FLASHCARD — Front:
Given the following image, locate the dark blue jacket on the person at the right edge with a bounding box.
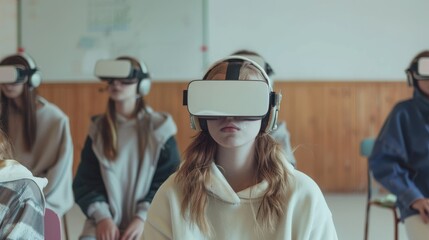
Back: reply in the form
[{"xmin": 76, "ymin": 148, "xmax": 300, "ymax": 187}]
[{"xmin": 369, "ymin": 89, "xmax": 429, "ymax": 220}]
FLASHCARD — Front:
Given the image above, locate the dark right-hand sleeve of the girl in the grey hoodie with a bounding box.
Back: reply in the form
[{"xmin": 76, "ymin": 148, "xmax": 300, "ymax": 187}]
[{"xmin": 137, "ymin": 136, "xmax": 180, "ymax": 219}]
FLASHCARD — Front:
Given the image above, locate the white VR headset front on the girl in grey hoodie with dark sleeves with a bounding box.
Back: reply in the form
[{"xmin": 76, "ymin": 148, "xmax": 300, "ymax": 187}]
[{"xmin": 94, "ymin": 60, "xmax": 138, "ymax": 84}]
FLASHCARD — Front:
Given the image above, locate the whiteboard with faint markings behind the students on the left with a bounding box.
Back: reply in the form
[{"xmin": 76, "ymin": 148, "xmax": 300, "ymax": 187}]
[{"xmin": 21, "ymin": 0, "xmax": 203, "ymax": 81}]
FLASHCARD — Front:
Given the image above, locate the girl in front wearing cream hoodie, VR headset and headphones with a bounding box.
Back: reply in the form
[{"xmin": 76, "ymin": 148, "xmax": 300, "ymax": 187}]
[{"xmin": 143, "ymin": 56, "xmax": 337, "ymax": 240}]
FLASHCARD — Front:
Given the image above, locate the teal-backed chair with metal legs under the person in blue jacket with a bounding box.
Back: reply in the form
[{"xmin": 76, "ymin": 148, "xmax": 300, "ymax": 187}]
[{"xmin": 360, "ymin": 137, "xmax": 400, "ymax": 240}]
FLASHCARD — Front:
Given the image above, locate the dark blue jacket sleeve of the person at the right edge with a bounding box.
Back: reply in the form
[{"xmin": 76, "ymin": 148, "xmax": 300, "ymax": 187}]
[{"xmin": 369, "ymin": 109, "xmax": 423, "ymax": 206}]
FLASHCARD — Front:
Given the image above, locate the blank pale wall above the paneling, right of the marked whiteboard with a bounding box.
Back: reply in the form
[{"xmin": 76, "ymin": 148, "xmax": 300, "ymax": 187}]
[{"xmin": 209, "ymin": 0, "xmax": 429, "ymax": 80}]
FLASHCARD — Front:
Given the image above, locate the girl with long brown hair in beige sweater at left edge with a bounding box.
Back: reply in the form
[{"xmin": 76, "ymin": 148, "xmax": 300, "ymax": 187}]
[{"xmin": 0, "ymin": 53, "xmax": 73, "ymax": 216}]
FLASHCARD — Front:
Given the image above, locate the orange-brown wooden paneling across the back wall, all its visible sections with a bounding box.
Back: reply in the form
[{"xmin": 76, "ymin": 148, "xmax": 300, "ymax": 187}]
[{"xmin": 39, "ymin": 82, "xmax": 412, "ymax": 192}]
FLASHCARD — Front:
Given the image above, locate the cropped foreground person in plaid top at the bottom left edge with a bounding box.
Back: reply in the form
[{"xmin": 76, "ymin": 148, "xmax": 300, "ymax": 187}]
[{"xmin": 0, "ymin": 129, "xmax": 47, "ymax": 240}]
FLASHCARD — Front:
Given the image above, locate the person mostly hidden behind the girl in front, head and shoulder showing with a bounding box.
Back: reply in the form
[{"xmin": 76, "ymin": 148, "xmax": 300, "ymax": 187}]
[{"xmin": 232, "ymin": 50, "xmax": 296, "ymax": 166}]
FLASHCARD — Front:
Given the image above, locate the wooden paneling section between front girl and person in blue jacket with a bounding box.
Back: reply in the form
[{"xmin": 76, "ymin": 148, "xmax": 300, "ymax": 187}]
[{"xmin": 276, "ymin": 82, "xmax": 412, "ymax": 191}]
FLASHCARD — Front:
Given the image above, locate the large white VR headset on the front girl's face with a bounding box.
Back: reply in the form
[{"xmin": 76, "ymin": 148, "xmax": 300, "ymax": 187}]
[{"xmin": 184, "ymin": 80, "xmax": 271, "ymax": 120}]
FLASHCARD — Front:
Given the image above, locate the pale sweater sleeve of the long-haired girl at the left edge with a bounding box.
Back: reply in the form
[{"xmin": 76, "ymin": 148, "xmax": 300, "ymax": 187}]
[{"xmin": 43, "ymin": 117, "xmax": 73, "ymax": 216}]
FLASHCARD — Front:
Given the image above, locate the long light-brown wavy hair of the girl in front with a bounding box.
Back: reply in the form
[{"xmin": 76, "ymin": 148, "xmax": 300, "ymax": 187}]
[{"xmin": 176, "ymin": 58, "xmax": 289, "ymax": 236}]
